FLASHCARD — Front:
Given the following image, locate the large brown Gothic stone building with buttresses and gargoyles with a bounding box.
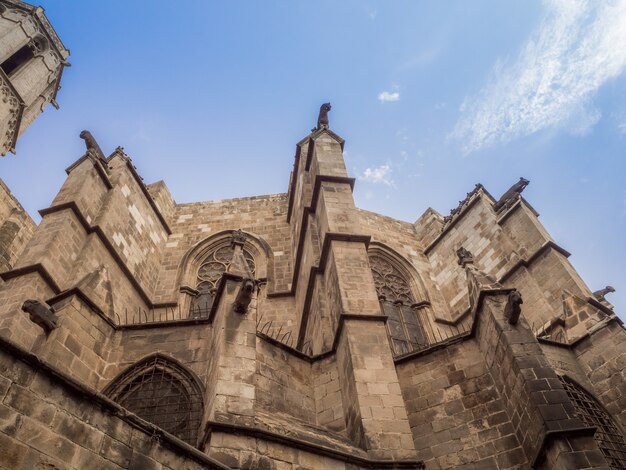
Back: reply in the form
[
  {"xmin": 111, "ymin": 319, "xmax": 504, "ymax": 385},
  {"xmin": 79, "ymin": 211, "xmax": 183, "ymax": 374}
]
[{"xmin": 0, "ymin": 0, "xmax": 626, "ymax": 470}]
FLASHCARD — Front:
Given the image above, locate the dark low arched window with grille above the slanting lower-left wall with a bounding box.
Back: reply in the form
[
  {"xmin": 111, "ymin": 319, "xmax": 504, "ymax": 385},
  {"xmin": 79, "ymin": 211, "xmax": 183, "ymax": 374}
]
[{"xmin": 104, "ymin": 355, "xmax": 203, "ymax": 446}]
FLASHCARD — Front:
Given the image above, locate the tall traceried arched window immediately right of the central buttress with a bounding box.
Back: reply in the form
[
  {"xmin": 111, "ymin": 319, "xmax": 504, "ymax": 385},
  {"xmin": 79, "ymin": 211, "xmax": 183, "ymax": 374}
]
[{"xmin": 369, "ymin": 255, "xmax": 427, "ymax": 355}]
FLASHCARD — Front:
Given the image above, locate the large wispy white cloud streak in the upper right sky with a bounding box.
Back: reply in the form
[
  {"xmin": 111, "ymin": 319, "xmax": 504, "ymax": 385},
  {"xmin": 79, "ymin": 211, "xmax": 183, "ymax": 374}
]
[{"xmin": 451, "ymin": 0, "xmax": 626, "ymax": 153}]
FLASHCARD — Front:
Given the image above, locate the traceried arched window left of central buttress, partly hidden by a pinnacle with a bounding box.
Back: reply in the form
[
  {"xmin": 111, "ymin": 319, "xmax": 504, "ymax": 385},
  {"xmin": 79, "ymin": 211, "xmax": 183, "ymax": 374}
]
[{"xmin": 189, "ymin": 241, "xmax": 255, "ymax": 318}]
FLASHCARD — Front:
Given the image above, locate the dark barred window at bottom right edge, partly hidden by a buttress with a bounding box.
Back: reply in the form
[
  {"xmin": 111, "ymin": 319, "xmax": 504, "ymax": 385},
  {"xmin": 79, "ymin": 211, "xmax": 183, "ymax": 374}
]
[{"xmin": 559, "ymin": 376, "xmax": 626, "ymax": 469}]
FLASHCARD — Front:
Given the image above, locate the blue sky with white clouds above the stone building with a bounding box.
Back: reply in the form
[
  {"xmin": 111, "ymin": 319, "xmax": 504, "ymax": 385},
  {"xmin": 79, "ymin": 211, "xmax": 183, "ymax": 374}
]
[{"xmin": 0, "ymin": 0, "xmax": 626, "ymax": 317}]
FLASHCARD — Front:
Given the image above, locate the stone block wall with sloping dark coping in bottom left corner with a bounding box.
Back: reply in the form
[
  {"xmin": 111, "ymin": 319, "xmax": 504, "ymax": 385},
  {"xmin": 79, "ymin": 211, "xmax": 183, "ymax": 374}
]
[{"xmin": 0, "ymin": 342, "xmax": 228, "ymax": 470}]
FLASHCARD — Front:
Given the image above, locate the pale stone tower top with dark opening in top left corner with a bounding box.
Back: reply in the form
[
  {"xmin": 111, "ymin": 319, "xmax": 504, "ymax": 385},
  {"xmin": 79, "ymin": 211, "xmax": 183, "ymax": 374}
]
[{"xmin": 0, "ymin": 0, "xmax": 70, "ymax": 156}]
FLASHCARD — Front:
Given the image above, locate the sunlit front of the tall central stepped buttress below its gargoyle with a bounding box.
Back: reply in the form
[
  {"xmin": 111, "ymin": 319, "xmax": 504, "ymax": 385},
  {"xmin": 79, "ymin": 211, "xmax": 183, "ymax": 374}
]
[{"xmin": 309, "ymin": 130, "xmax": 416, "ymax": 459}]
